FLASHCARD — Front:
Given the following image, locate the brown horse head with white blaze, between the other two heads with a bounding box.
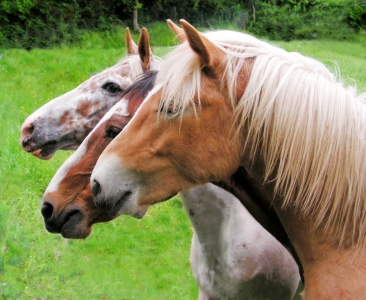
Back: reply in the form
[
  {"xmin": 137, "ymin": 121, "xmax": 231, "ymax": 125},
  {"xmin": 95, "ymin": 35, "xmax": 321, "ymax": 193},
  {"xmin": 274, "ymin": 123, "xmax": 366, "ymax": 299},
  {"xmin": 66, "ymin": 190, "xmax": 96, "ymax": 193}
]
[{"xmin": 41, "ymin": 72, "xmax": 155, "ymax": 238}]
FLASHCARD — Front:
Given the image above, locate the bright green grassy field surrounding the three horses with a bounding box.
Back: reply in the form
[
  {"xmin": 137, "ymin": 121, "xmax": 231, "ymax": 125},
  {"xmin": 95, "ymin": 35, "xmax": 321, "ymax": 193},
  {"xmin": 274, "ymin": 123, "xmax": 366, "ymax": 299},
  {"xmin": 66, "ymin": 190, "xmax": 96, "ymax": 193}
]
[{"xmin": 0, "ymin": 26, "xmax": 366, "ymax": 300}]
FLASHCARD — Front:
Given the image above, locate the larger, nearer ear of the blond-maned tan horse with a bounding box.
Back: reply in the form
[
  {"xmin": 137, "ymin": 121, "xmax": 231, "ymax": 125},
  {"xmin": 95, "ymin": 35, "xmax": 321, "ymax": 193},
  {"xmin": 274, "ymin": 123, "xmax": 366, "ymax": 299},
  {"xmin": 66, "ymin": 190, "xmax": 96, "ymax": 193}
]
[{"xmin": 180, "ymin": 19, "xmax": 225, "ymax": 69}]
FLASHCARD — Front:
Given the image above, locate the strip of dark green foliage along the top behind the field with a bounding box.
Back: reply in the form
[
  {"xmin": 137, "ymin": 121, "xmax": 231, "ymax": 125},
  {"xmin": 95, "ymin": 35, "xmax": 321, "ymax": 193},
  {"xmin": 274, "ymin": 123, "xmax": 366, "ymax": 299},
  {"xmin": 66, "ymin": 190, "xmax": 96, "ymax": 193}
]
[{"xmin": 0, "ymin": 0, "xmax": 366, "ymax": 49}]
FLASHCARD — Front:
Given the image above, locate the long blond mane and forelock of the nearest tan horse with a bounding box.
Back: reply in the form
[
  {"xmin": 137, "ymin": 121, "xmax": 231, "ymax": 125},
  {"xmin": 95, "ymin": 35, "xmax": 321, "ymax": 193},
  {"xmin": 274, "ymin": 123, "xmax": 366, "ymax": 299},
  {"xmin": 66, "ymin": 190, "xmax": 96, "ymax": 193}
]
[{"xmin": 156, "ymin": 31, "xmax": 366, "ymax": 246}]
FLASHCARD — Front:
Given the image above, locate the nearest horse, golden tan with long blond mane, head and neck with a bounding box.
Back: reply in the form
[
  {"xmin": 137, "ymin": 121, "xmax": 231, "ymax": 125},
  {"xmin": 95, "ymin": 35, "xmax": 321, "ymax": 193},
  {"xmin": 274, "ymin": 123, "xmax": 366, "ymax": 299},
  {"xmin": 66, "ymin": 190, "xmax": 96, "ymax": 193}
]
[{"xmin": 91, "ymin": 20, "xmax": 366, "ymax": 299}]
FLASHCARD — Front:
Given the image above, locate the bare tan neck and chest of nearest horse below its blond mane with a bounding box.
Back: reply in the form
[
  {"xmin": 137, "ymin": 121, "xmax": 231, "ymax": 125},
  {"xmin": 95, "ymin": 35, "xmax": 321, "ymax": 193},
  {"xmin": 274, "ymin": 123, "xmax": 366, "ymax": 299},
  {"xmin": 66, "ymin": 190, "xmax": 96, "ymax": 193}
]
[{"xmin": 242, "ymin": 156, "xmax": 366, "ymax": 299}]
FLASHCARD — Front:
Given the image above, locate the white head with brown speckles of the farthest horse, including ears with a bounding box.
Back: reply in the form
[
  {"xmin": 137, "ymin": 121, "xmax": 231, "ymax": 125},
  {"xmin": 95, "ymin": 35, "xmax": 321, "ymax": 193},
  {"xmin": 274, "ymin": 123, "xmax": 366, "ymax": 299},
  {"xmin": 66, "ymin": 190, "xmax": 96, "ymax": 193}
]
[{"xmin": 20, "ymin": 28, "xmax": 160, "ymax": 159}]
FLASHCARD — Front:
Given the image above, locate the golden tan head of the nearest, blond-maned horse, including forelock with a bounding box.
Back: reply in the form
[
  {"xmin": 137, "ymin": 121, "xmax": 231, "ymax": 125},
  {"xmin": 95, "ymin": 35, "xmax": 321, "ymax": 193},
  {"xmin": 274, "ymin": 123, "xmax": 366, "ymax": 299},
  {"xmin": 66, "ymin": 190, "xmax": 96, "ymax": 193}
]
[{"xmin": 91, "ymin": 21, "xmax": 251, "ymax": 214}]
